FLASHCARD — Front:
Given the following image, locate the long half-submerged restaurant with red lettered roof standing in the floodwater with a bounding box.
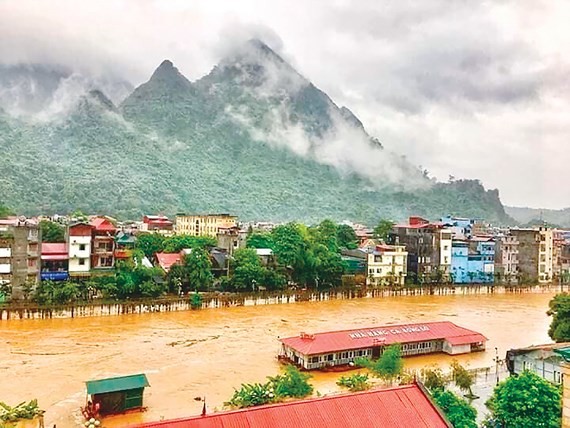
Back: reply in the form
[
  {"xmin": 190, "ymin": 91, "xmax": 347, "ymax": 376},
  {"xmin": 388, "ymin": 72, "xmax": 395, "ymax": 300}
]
[{"xmin": 279, "ymin": 321, "xmax": 487, "ymax": 370}]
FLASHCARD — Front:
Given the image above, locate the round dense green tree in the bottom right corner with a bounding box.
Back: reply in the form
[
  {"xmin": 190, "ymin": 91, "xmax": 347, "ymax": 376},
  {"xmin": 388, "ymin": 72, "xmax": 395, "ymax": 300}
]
[{"xmin": 485, "ymin": 371, "xmax": 562, "ymax": 428}]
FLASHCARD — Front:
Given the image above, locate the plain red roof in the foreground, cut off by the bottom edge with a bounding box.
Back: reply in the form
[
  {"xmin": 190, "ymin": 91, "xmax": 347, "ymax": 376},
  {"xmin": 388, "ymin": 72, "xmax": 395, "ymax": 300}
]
[{"xmin": 133, "ymin": 385, "xmax": 452, "ymax": 428}]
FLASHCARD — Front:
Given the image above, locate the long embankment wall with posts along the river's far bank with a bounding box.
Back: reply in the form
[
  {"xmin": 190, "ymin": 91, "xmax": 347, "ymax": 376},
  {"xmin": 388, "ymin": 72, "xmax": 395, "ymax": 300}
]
[{"xmin": 0, "ymin": 284, "xmax": 560, "ymax": 321}]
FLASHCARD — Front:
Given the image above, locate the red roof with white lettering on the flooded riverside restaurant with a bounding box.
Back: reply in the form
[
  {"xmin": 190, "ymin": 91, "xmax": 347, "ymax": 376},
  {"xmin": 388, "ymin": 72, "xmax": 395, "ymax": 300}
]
[{"xmin": 280, "ymin": 321, "xmax": 487, "ymax": 355}]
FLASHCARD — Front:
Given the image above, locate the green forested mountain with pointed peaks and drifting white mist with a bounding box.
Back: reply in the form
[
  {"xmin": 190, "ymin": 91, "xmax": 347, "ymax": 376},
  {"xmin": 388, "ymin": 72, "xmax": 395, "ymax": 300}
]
[{"xmin": 0, "ymin": 41, "xmax": 508, "ymax": 224}]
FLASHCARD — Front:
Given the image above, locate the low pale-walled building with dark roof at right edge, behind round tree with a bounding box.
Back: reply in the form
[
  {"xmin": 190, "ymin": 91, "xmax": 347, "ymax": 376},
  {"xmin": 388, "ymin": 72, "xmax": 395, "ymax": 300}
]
[{"xmin": 506, "ymin": 342, "xmax": 570, "ymax": 384}]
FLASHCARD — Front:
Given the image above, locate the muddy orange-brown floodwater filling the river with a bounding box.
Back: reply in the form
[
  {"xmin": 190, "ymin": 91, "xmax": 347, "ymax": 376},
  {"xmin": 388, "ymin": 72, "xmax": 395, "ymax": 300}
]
[{"xmin": 0, "ymin": 293, "xmax": 553, "ymax": 428}]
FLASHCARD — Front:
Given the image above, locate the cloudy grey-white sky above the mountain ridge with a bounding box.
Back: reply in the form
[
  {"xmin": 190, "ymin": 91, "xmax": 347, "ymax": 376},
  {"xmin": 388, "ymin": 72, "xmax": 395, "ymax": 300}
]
[{"xmin": 0, "ymin": 0, "xmax": 570, "ymax": 208}]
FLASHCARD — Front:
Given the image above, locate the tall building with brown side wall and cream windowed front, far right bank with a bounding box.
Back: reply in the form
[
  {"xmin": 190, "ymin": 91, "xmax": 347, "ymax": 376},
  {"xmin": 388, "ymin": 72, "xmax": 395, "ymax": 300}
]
[{"xmin": 511, "ymin": 227, "xmax": 553, "ymax": 283}]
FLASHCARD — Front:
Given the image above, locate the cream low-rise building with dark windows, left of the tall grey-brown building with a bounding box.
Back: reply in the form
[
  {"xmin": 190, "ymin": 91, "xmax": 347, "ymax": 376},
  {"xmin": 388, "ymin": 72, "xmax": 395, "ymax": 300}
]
[{"xmin": 365, "ymin": 244, "xmax": 408, "ymax": 286}]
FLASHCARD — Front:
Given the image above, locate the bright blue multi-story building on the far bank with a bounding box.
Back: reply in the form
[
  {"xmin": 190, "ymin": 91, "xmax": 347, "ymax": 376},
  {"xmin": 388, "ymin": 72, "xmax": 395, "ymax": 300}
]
[{"xmin": 451, "ymin": 236, "xmax": 495, "ymax": 284}]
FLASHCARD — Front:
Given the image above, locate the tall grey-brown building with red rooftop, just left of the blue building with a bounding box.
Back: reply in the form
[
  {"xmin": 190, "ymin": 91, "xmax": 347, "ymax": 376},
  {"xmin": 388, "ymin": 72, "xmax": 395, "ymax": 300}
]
[{"xmin": 388, "ymin": 217, "xmax": 451, "ymax": 281}]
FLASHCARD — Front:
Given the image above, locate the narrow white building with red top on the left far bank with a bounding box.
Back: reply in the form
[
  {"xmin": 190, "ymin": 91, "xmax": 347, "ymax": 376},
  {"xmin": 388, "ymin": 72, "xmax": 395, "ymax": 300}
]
[{"xmin": 67, "ymin": 222, "xmax": 93, "ymax": 277}]
